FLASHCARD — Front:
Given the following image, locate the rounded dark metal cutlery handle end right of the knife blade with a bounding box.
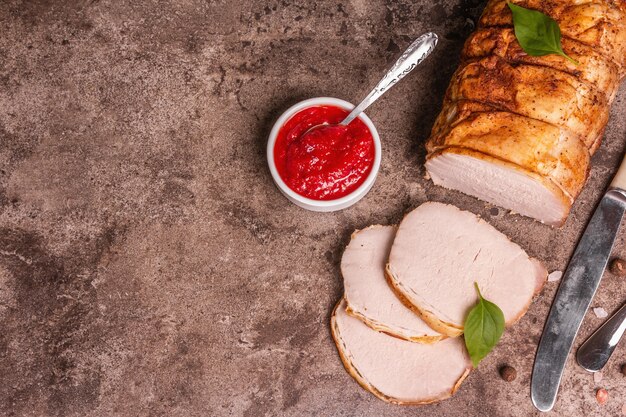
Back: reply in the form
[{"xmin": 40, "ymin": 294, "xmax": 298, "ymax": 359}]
[{"xmin": 576, "ymin": 304, "xmax": 626, "ymax": 372}]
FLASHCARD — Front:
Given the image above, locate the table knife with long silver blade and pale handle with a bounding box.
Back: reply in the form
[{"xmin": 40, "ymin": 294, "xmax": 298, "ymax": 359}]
[{"xmin": 530, "ymin": 159, "xmax": 626, "ymax": 411}]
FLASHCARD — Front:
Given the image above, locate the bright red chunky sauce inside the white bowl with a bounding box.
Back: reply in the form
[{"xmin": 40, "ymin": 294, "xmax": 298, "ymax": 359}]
[{"xmin": 274, "ymin": 106, "xmax": 375, "ymax": 200}]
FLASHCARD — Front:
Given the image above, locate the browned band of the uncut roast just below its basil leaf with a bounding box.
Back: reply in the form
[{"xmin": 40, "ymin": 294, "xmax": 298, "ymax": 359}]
[{"xmin": 462, "ymin": 27, "xmax": 620, "ymax": 102}]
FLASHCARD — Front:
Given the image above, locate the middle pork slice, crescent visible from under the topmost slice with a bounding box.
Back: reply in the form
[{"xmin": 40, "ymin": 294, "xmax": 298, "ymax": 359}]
[{"xmin": 341, "ymin": 226, "xmax": 444, "ymax": 343}]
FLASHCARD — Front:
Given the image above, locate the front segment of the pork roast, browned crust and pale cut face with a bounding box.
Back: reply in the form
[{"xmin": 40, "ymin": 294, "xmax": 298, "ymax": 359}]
[{"xmin": 426, "ymin": 101, "xmax": 590, "ymax": 225}]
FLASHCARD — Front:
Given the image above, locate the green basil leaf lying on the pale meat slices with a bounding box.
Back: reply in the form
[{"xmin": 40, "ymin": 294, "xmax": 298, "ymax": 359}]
[{"xmin": 464, "ymin": 283, "xmax": 504, "ymax": 367}]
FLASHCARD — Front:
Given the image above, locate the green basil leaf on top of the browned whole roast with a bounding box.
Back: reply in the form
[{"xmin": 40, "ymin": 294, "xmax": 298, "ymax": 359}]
[{"xmin": 507, "ymin": 3, "xmax": 578, "ymax": 65}]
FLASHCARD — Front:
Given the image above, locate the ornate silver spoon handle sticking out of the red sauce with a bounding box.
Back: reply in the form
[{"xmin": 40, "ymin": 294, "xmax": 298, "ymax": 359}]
[{"xmin": 340, "ymin": 32, "xmax": 439, "ymax": 126}]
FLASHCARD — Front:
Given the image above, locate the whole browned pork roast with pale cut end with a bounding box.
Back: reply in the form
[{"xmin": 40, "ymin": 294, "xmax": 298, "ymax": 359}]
[{"xmin": 426, "ymin": 0, "xmax": 626, "ymax": 225}]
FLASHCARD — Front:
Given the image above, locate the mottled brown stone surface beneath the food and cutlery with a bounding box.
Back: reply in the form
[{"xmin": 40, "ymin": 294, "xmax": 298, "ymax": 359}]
[{"xmin": 0, "ymin": 0, "xmax": 626, "ymax": 416}]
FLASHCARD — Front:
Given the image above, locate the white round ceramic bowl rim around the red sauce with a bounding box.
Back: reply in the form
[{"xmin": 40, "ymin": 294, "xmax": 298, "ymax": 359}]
[{"xmin": 267, "ymin": 97, "xmax": 381, "ymax": 211}]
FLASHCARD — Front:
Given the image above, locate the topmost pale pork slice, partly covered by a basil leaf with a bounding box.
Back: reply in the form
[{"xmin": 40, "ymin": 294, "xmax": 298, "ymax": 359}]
[{"xmin": 387, "ymin": 202, "xmax": 547, "ymax": 337}]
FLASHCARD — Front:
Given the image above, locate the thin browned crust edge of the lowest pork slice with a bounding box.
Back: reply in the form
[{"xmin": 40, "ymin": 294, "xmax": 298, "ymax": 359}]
[{"xmin": 330, "ymin": 298, "xmax": 472, "ymax": 405}]
